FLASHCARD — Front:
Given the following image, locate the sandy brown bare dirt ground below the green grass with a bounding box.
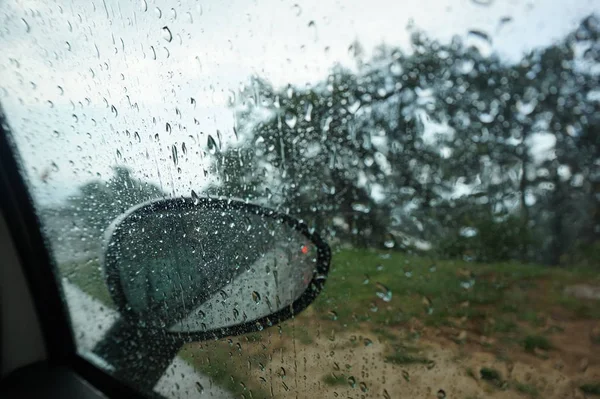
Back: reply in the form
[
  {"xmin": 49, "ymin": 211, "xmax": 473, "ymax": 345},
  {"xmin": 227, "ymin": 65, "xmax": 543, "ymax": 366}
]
[{"xmin": 240, "ymin": 321, "xmax": 600, "ymax": 399}]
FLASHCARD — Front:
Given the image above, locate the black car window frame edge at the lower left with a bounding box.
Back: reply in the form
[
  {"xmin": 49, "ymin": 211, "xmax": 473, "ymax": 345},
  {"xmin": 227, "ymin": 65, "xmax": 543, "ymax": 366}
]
[{"xmin": 0, "ymin": 107, "xmax": 147, "ymax": 398}]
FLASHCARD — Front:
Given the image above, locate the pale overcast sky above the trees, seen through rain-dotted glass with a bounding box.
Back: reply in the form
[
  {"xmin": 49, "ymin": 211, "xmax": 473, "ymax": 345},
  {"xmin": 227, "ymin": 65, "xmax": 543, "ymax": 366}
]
[{"xmin": 0, "ymin": 0, "xmax": 600, "ymax": 203}]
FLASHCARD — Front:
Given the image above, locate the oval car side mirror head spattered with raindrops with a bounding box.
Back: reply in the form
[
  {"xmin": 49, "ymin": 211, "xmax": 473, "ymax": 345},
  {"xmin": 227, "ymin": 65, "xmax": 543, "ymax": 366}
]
[{"xmin": 104, "ymin": 198, "xmax": 331, "ymax": 339}]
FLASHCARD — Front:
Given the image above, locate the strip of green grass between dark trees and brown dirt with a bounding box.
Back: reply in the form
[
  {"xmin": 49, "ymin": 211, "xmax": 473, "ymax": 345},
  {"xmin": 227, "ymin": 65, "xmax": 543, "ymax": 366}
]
[{"xmin": 313, "ymin": 249, "xmax": 600, "ymax": 333}]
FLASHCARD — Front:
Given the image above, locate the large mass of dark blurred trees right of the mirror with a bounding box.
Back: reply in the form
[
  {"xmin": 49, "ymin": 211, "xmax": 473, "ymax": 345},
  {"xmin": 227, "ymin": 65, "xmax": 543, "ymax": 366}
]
[{"xmin": 212, "ymin": 16, "xmax": 600, "ymax": 264}]
